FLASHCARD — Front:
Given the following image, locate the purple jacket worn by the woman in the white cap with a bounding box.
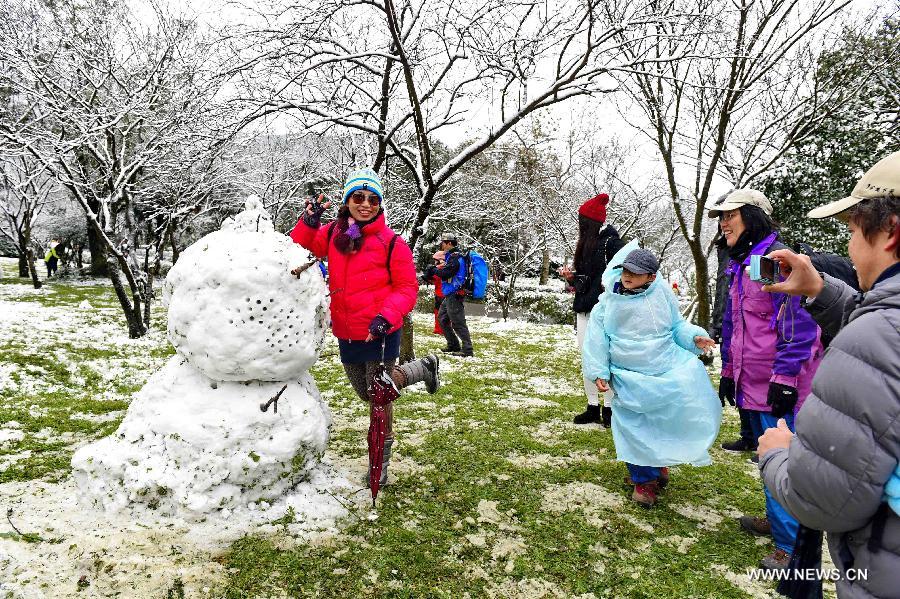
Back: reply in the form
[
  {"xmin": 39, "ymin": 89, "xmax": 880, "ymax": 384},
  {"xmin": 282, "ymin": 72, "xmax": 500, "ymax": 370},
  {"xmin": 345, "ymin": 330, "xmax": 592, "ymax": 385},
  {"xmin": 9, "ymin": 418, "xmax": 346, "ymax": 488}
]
[{"xmin": 722, "ymin": 233, "xmax": 823, "ymax": 414}]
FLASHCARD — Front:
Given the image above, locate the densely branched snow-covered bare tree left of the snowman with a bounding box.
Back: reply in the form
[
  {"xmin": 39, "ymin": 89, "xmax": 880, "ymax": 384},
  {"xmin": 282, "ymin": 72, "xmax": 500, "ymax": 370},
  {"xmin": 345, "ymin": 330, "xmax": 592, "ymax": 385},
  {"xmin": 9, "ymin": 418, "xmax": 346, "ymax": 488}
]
[{"xmin": 0, "ymin": 2, "xmax": 236, "ymax": 337}]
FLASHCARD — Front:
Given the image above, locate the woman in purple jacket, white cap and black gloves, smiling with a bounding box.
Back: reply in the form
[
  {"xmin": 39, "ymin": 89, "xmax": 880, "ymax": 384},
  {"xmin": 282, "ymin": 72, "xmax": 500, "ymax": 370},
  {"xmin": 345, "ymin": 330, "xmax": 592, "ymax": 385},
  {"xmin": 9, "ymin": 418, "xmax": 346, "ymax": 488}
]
[{"xmin": 709, "ymin": 189, "xmax": 823, "ymax": 569}]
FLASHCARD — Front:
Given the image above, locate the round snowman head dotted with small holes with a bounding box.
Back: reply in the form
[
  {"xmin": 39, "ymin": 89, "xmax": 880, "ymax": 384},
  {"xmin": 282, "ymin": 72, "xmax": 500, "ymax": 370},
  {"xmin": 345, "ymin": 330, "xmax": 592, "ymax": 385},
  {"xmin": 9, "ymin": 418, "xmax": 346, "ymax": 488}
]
[{"xmin": 163, "ymin": 196, "xmax": 328, "ymax": 381}]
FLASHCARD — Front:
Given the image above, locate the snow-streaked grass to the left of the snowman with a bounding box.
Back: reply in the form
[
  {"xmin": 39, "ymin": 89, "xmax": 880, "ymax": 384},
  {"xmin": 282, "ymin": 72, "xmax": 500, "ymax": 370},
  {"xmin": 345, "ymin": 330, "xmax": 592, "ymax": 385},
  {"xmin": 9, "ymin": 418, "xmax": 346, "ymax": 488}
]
[{"xmin": 0, "ymin": 261, "xmax": 172, "ymax": 483}]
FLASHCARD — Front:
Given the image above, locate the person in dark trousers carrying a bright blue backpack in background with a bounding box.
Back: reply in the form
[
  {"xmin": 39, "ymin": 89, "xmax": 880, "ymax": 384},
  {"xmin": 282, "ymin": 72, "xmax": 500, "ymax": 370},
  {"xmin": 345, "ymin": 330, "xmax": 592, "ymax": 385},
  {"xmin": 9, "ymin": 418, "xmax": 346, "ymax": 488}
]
[{"xmin": 434, "ymin": 233, "xmax": 475, "ymax": 358}]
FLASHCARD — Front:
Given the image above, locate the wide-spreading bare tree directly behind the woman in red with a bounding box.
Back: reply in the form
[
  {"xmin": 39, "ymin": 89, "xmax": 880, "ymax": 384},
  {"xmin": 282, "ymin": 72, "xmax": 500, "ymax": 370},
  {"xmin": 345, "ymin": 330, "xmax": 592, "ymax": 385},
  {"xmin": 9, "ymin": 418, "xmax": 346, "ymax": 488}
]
[{"xmin": 232, "ymin": 0, "xmax": 696, "ymax": 356}]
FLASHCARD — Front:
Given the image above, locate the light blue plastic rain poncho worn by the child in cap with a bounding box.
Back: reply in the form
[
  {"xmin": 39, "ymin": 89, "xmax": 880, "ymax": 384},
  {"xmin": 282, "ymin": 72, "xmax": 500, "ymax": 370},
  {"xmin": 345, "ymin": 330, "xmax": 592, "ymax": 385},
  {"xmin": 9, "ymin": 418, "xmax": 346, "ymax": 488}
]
[{"xmin": 582, "ymin": 241, "xmax": 722, "ymax": 467}]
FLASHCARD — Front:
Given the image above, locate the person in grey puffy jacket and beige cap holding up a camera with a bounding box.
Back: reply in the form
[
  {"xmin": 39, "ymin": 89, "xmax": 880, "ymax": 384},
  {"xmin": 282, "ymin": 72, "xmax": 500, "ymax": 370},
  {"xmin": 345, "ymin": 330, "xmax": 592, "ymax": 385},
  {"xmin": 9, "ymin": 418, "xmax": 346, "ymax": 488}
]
[{"xmin": 759, "ymin": 152, "xmax": 900, "ymax": 599}]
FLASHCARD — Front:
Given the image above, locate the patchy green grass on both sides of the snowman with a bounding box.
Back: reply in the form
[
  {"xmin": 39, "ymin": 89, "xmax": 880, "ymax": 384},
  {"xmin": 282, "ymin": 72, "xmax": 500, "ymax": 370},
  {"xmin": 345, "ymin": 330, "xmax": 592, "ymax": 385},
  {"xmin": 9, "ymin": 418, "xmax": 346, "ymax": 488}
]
[{"xmin": 0, "ymin": 264, "xmax": 800, "ymax": 598}]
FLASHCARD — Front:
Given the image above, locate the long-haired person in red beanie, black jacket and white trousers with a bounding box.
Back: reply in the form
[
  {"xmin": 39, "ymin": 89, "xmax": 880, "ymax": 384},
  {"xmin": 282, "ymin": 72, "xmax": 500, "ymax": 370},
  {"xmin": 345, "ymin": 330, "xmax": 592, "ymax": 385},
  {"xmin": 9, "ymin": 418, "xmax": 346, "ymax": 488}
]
[{"xmin": 559, "ymin": 193, "xmax": 625, "ymax": 428}]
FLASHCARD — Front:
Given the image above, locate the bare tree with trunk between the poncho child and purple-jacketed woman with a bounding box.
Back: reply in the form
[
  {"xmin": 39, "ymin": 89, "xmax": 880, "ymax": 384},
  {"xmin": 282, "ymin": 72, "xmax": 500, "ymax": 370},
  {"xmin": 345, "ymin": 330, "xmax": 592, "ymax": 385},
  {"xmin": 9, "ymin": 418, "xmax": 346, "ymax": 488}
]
[{"xmin": 604, "ymin": 0, "xmax": 856, "ymax": 326}]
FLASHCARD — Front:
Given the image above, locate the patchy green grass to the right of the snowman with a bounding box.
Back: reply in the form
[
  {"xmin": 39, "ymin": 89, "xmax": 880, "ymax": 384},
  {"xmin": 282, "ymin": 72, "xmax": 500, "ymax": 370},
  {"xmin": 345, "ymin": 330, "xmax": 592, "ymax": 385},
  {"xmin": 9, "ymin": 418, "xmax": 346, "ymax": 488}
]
[{"xmin": 223, "ymin": 328, "xmax": 771, "ymax": 597}]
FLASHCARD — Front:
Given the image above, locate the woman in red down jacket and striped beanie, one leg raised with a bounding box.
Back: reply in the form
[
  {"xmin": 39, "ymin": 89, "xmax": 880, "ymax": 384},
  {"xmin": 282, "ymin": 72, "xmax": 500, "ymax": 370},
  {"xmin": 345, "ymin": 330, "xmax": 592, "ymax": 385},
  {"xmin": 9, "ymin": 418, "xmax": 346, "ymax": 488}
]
[{"xmin": 291, "ymin": 168, "xmax": 440, "ymax": 485}]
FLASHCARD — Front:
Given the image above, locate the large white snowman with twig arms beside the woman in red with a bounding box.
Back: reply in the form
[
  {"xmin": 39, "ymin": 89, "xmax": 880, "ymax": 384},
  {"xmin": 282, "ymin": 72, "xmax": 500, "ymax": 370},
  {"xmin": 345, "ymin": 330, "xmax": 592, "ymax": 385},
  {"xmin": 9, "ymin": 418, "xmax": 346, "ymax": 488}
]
[{"xmin": 72, "ymin": 196, "xmax": 331, "ymax": 519}]
